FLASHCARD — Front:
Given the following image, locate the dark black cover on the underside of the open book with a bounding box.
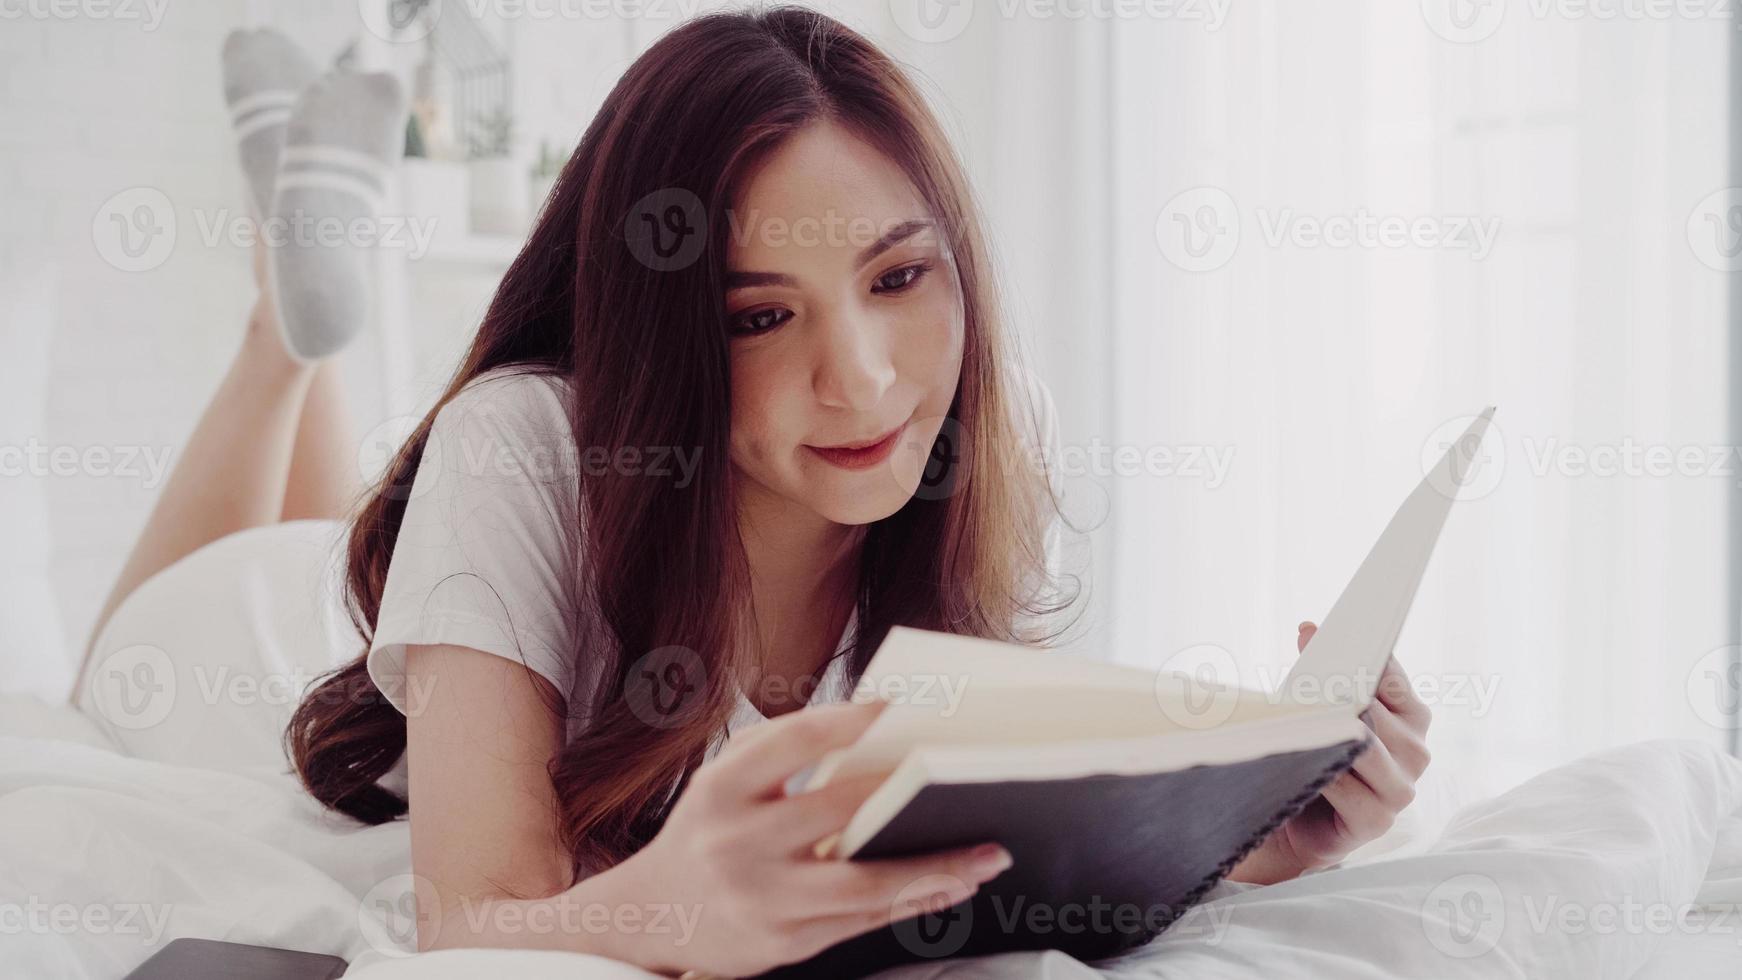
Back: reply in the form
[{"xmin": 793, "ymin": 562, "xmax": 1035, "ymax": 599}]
[{"xmin": 763, "ymin": 742, "xmax": 1366, "ymax": 980}]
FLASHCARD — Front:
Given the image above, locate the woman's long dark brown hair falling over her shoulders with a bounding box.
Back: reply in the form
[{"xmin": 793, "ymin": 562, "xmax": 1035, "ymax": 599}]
[{"xmin": 286, "ymin": 7, "xmax": 1063, "ymax": 876}]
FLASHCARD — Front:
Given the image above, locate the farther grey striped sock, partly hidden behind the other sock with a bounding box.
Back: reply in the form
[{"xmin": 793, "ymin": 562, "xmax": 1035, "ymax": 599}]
[{"xmin": 223, "ymin": 30, "xmax": 315, "ymax": 214}]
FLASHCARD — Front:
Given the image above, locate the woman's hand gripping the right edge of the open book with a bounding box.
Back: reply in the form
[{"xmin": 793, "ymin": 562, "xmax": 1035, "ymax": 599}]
[{"xmin": 1228, "ymin": 623, "xmax": 1432, "ymax": 884}]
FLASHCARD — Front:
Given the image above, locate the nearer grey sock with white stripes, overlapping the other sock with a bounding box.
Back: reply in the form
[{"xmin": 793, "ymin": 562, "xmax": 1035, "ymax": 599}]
[{"xmin": 270, "ymin": 70, "xmax": 406, "ymax": 360}]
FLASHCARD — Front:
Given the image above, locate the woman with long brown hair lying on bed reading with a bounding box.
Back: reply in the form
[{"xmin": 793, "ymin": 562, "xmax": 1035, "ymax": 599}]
[{"xmin": 71, "ymin": 9, "xmax": 1427, "ymax": 975}]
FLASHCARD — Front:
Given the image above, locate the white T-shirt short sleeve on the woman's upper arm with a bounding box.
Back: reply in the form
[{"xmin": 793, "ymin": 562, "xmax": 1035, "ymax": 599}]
[{"xmin": 368, "ymin": 373, "xmax": 578, "ymax": 712}]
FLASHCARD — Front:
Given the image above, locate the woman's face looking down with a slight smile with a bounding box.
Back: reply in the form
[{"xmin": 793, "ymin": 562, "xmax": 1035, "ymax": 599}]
[{"xmin": 726, "ymin": 124, "xmax": 963, "ymax": 524}]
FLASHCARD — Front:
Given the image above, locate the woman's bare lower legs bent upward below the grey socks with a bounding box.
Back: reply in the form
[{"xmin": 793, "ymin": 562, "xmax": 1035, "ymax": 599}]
[{"xmin": 71, "ymin": 247, "xmax": 333, "ymax": 703}]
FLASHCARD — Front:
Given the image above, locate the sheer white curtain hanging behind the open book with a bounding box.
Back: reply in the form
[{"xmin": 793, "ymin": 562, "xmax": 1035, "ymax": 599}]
[{"xmin": 1100, "ymin": 0, "xmax": 1742, "ymax": 789}]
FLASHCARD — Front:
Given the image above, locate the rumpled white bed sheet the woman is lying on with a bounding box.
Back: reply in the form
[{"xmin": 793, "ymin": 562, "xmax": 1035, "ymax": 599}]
[{"xmin": 0, "ymin": 696, "xmax": 1742, "ymax": 980}]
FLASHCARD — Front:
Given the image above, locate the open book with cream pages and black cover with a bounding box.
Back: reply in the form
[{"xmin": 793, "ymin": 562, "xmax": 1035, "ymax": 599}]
[{"xmin": 773, "ymin": 407, "xmax": 1493, "ymax": 977}]
